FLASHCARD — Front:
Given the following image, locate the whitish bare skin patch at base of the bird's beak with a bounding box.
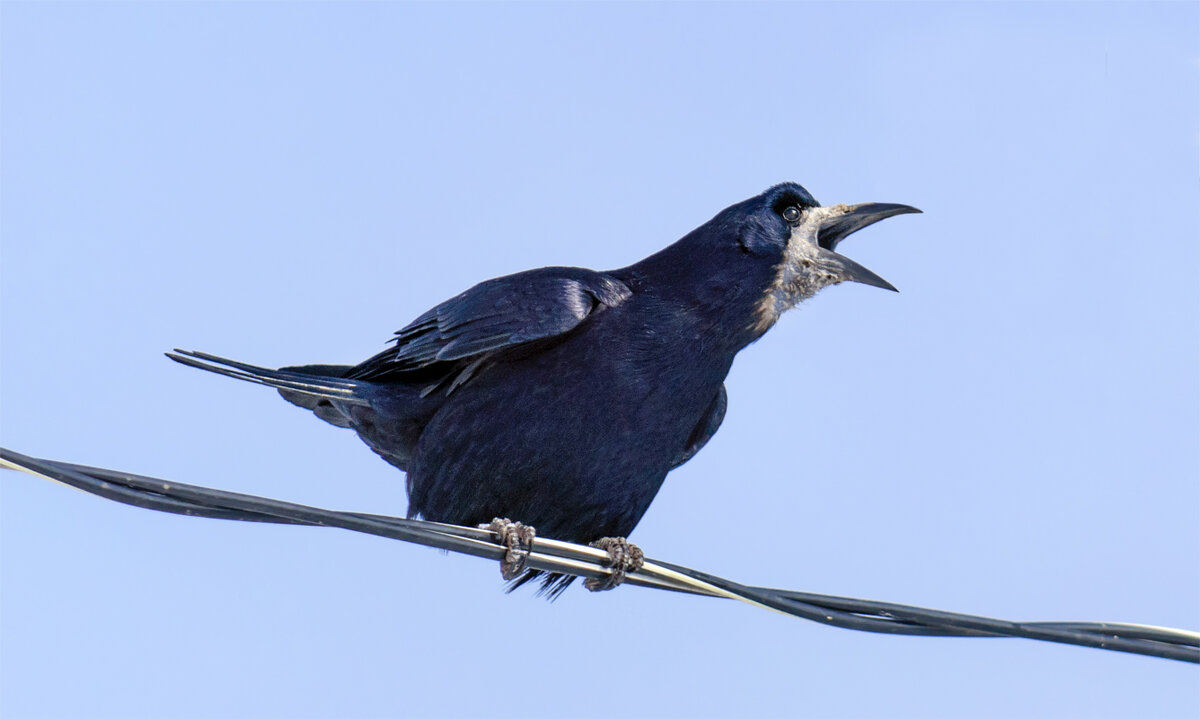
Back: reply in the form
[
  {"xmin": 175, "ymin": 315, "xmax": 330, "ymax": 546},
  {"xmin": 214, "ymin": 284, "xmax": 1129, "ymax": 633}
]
[{"xmin": 755, "ymin": 204, "xmax": 850, "ymax": 331}]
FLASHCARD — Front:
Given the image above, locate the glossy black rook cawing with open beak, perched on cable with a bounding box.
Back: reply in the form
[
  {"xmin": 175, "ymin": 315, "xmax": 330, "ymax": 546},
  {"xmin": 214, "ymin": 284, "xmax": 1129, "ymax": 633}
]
[{"xmin": 168, "ymin": 182, "xmax": 920, "ymax": 594}]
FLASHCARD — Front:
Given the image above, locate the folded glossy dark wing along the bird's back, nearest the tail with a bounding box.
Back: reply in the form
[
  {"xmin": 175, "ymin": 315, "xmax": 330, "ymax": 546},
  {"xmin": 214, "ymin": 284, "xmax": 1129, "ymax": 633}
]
[{"xmin": 349, "ymin": 268, "xmax": 632, "ymax": 381}]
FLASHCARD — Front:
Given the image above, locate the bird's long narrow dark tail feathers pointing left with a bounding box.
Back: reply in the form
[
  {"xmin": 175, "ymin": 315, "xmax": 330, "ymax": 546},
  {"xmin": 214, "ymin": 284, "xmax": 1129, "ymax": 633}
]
[{"xmin": 167, "ymin": 349, "xmax": 370, "ymax": 412}]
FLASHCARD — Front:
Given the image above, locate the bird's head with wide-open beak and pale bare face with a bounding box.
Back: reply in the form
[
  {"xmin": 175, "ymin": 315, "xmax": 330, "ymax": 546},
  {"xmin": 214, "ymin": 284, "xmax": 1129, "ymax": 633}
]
[{"xmin": 722, "ymin": 182, "xmax": 920, "ymax": 334}]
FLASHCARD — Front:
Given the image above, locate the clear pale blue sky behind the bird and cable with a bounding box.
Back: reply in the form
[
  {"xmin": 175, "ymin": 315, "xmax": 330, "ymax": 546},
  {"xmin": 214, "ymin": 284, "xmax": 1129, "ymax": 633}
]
[{"xmin": 0, "ymin": 1, "xmax": 1200, "ymax": 718}]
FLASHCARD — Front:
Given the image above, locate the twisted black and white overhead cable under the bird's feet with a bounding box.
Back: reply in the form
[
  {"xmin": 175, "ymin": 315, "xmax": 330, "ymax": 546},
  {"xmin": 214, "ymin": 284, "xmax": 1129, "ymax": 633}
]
[{"xmin": 0, "ymin": 448, "xmax": 1200, "ymax": 664}]
